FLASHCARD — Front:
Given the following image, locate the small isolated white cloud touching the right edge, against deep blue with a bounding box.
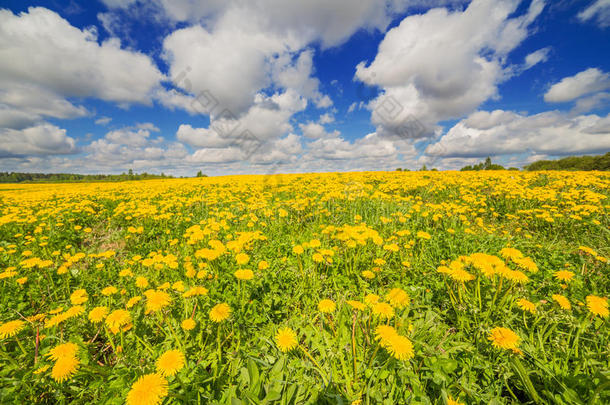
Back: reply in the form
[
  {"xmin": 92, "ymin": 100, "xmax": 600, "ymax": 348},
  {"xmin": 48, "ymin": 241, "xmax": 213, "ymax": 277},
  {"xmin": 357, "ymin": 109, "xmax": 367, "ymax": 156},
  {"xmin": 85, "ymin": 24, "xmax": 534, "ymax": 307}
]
[{"xmin": 544, "ymin": 68, "xmax": 610, "ymax": 103}]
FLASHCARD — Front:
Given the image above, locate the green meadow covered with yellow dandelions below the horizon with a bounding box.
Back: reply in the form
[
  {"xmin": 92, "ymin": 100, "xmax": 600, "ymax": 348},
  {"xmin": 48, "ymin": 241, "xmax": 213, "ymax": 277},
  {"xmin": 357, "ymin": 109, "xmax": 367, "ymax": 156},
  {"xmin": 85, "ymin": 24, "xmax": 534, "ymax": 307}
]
[{"xmin": 0, "ymin": 171, "xmax": 610, "ymax": 405}]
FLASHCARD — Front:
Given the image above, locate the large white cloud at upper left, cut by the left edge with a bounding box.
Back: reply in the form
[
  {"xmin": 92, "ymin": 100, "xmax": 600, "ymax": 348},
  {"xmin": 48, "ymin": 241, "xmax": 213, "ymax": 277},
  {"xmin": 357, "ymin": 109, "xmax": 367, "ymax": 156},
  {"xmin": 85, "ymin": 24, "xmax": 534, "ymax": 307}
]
[{"xmin": 0, "ymin": 7, "xmax": 163, "ymax": 104}]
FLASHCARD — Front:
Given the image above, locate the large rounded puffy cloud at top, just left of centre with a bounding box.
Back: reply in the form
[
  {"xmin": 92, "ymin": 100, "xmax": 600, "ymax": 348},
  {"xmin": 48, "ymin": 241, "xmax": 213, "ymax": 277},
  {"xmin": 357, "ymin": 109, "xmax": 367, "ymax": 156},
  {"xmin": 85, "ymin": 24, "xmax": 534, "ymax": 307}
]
[{"xmin": 163, "ymin": 13, "xmax": 332, "ymax": 119}]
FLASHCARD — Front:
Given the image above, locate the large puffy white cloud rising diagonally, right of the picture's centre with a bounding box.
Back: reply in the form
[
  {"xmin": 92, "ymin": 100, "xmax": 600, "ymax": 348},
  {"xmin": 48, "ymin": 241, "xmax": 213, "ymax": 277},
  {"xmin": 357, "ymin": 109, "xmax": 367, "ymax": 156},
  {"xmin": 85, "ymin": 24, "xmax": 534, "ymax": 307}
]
[{"xmin": 356, "ymin": 0, "xmax": 544, "ymax": 133}]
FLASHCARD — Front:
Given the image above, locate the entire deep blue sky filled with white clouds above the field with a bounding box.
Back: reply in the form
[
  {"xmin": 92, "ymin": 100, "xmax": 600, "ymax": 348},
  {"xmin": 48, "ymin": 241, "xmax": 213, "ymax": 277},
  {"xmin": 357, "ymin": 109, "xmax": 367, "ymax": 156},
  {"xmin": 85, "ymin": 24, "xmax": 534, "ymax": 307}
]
[{"xmin": 0, "ymin": 0, "xmax": 610, "ymax": 176}]
